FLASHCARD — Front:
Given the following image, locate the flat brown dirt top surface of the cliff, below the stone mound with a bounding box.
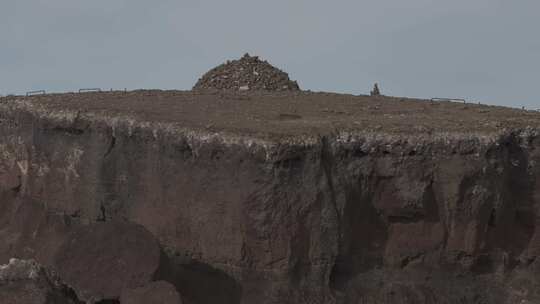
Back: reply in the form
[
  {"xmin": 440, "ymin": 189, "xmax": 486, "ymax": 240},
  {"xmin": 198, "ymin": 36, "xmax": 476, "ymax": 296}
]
[{"xmin": 5, "ymin": 90, "xmax": 540, "ymax": 136}]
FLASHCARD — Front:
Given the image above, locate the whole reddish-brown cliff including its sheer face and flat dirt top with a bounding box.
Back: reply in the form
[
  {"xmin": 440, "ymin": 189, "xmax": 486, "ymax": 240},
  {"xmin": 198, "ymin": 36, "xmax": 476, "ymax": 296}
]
[{"xmin": 0, "ymin": 90, "xmax": 540, "ymax": 304}]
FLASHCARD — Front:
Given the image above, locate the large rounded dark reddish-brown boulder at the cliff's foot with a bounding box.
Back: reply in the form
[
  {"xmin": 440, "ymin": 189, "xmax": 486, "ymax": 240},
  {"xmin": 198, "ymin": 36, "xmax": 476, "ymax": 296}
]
[{"xmin": 55, "ymin": 221, "xmax": 160, "ymax": 301}]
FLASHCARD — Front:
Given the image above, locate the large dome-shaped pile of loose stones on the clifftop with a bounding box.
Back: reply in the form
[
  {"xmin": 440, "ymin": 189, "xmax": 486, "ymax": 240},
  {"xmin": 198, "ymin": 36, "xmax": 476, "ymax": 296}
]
[{"xmin": 193, "ymin": 54, "xmax": 300, "ymax": 91}]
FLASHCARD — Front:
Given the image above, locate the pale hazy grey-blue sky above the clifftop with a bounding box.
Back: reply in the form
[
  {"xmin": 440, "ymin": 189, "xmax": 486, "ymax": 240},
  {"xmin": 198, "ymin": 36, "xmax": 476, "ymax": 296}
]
[{"xmin": 0, "ymin": 0, "xmax": 540, "ymax": 109}]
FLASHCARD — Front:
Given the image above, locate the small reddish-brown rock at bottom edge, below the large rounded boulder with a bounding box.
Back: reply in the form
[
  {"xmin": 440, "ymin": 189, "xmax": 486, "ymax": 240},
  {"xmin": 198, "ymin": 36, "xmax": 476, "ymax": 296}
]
[{"xmin": 120, "ymin": 281, "xmax": 182, "ymax": 304}]
